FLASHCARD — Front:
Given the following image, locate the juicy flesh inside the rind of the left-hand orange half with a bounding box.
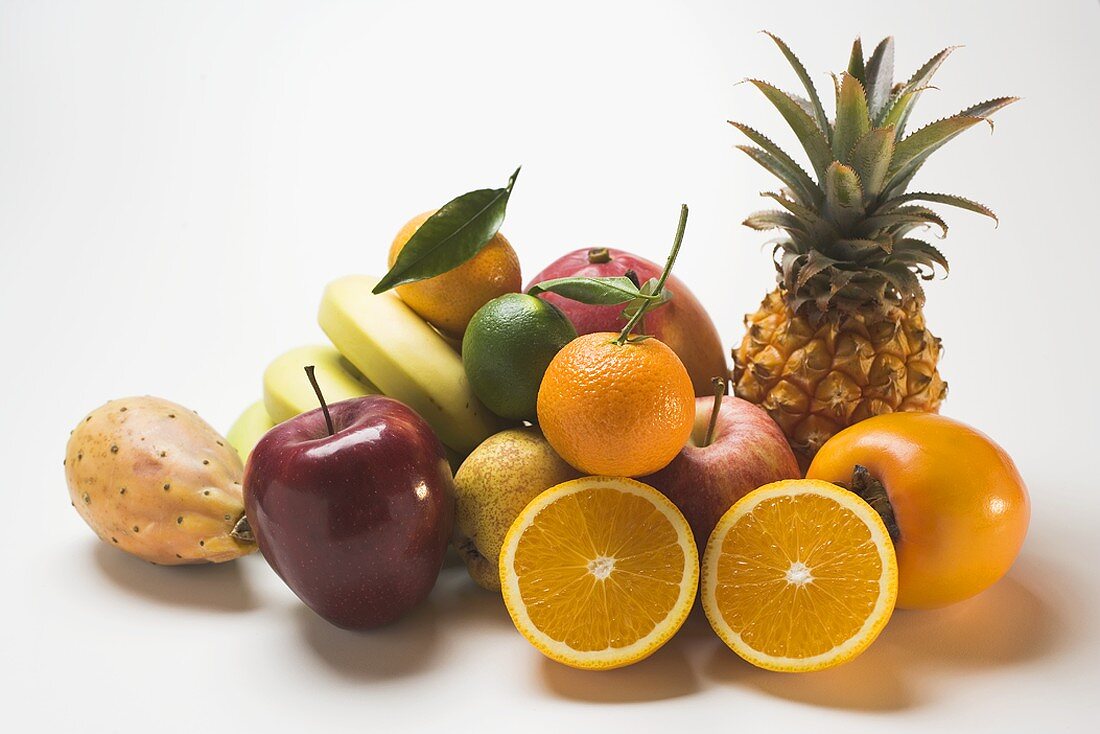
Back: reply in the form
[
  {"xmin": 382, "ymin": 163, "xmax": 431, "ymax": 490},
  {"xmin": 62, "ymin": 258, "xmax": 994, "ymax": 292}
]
[{"xmin": 514, "ymin": 487, "xmax": 685, "ymax": 651}]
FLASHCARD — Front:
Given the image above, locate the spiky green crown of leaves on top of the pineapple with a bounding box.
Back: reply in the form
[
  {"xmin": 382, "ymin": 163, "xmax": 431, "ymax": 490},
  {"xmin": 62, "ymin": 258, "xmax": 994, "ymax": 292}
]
[{"xmin": 730, "ymin": 31, "xmax": 1018, "ymax": 321}]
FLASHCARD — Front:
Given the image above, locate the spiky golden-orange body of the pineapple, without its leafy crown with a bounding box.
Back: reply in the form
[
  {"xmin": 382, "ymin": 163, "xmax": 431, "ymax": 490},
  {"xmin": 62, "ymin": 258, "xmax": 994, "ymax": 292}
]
[{"xmin": 734, "ymin": 288, "xmax": 947, "ymax": 459}]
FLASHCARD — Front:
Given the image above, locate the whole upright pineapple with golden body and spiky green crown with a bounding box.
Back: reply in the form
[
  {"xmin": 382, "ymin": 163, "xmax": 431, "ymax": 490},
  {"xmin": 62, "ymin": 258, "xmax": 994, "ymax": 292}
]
[{"xmin": 730, "ymin": 34, "xmax": 1016, "ymax": 461}]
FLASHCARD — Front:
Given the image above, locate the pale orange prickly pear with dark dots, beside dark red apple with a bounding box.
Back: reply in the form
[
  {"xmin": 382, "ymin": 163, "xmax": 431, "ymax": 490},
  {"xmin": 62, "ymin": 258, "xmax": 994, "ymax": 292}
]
[{"xmin": 65, "ymin": 397, "xmax": 255, "ymax": 565}]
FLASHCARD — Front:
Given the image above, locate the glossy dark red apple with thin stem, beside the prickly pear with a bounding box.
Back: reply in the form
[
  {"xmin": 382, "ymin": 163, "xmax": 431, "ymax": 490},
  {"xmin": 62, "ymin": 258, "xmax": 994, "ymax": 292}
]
[{"xmin": 244, "ymin": 395, "xmax": 454, "ymax": 628}]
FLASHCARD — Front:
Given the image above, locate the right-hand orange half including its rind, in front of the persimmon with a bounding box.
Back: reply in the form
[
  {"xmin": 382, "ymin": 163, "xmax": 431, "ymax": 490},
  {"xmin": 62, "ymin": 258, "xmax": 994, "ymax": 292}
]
[{"xmin": 702, "ymin": 479, "xmax": 898, "ymax": 672}]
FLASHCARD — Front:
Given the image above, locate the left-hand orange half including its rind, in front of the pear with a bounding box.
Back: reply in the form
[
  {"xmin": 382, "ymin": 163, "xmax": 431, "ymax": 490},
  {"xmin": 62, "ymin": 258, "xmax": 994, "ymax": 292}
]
[{"xmin": 501, "ymin": 476, "xmax": 699, "ymax": 669}]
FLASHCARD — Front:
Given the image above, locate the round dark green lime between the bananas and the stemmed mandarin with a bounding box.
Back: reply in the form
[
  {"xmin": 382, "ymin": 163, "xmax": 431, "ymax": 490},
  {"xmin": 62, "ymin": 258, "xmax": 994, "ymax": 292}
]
[{"xmin": 462, "ymin": 293, "xmax": 576, "ymax": 421}]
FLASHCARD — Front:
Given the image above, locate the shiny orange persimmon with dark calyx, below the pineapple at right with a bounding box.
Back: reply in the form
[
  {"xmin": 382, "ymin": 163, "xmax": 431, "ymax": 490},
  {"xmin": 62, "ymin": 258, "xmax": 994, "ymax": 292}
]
[{"xmin": 806, "ymin": 413, "xmax": 1031, "ymax": 609}]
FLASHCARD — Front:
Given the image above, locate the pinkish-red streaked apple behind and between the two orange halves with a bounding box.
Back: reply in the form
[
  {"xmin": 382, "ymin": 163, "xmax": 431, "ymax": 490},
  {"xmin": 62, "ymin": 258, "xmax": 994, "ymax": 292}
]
[{"xmin": 639, "ymin": 396, "xmax": 802, "ymax": 555}]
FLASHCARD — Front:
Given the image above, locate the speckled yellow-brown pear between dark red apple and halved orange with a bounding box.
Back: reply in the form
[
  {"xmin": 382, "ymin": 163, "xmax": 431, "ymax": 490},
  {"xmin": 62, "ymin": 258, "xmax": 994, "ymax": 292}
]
[{"xmin": 453, "ymin": 427, "xmax": 580, "ymax": 591}]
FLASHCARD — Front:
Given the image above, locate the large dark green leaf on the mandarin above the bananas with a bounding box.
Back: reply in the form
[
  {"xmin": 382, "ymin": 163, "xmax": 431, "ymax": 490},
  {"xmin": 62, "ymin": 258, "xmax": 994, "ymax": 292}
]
[{"xmin": 374, "ymin": 168, "xmax": 519, "ymax": 294}]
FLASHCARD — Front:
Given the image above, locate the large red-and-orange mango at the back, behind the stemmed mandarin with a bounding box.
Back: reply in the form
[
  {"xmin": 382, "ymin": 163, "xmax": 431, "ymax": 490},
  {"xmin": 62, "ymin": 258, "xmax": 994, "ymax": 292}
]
[{"xmin": 527, "ymin": 248, "xmax": 729, "ymax": 395}]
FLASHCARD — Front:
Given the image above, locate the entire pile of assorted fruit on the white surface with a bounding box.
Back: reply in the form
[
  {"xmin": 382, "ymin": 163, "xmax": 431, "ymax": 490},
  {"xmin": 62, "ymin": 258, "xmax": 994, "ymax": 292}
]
[{"xmin": 65, "ymin": 36, "xmax": 1030, "ymax": 671}]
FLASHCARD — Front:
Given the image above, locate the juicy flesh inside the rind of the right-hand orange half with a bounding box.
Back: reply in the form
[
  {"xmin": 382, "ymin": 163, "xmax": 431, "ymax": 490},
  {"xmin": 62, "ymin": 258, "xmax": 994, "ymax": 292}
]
[{"xmin": 715, "ymin": 495, "xmax": 882, "ymax": 658}]
